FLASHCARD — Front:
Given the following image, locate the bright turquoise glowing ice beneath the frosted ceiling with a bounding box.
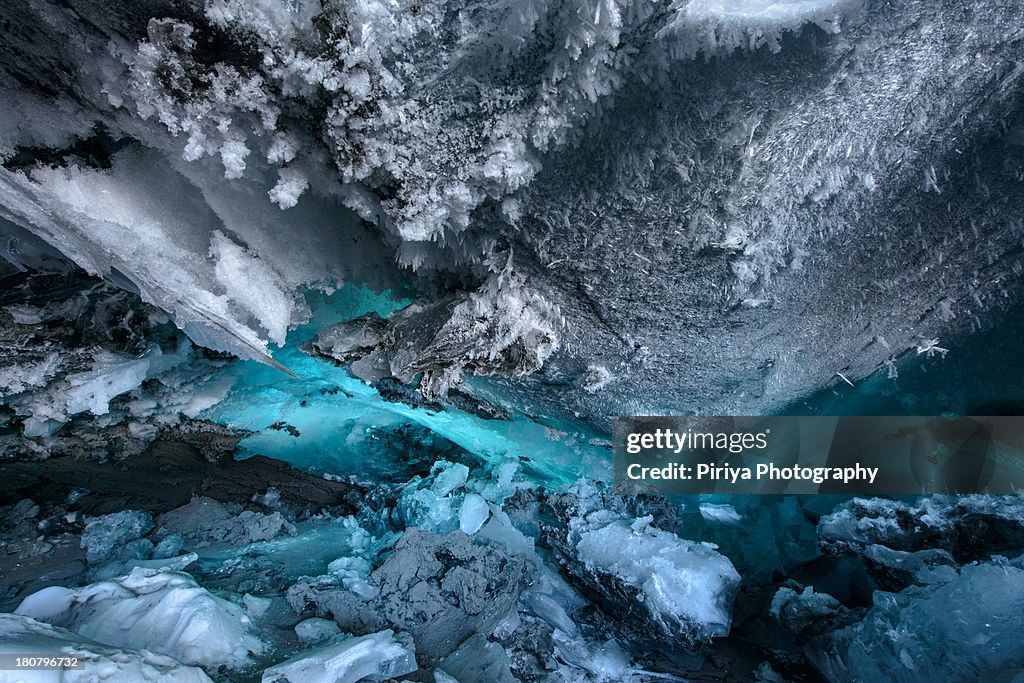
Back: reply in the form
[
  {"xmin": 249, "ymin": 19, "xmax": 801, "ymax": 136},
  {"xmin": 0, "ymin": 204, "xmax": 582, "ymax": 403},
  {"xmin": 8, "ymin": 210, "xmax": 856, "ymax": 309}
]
[{"xmin": 202, "ymin": 286, "xmax": 610, "ymax": 485}]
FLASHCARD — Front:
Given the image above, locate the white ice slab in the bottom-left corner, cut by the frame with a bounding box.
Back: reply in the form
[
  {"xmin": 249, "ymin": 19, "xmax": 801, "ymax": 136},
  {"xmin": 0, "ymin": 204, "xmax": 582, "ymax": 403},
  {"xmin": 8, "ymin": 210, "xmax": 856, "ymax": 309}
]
[{"xmin": 0, "ymin": 614, "xmax": 211, "ymax": 683}]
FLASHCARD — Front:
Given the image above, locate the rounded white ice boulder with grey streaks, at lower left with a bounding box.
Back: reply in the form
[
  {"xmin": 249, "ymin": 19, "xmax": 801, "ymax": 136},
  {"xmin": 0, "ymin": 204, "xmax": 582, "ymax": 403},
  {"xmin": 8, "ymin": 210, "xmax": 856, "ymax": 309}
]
[{"xmin": 15, "ymin": 567, "xmax": 263, "ymax": 669}]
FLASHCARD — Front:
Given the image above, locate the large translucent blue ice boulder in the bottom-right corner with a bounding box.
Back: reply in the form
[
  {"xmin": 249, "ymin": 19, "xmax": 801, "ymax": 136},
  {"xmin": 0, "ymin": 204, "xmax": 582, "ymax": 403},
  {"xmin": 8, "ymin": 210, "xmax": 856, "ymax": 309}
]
[{"xmin": 806, "ymin": 559, "xmax": 1024, "ymax": 683}]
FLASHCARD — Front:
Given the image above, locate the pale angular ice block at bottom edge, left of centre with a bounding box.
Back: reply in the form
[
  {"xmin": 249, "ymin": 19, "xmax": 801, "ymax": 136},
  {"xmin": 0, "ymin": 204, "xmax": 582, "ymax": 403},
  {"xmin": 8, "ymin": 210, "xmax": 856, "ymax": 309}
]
[{"xmin": 263, "ymin": 631, "xmax": 417, "ymax": 683}]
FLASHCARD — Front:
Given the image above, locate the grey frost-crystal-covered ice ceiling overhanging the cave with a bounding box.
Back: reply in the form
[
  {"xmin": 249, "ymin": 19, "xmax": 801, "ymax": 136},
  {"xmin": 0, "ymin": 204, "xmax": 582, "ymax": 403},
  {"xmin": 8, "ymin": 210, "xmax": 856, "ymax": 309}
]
[{"xmin": 0, "ymin": 0, "xmax": 1024, "ymax": 422}]
